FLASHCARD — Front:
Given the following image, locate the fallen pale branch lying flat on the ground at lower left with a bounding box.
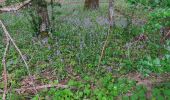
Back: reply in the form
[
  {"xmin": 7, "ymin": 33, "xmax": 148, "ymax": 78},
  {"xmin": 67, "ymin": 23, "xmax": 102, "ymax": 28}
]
[{"xmin": 15, "ymin": 84, "xmax": 68, "ymax": 94}]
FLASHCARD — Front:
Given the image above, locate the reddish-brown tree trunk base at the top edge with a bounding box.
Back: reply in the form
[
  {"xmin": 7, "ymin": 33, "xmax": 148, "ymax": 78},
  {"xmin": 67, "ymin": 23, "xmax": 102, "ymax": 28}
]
[{"xmin": 84, "ymin": 0, "xmax": 99, "ymax": 9}]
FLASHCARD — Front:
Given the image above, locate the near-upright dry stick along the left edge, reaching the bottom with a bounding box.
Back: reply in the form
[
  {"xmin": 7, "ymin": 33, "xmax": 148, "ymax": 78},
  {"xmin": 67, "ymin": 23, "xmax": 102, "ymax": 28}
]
[{"xmin": 2, "ymin": 34, "xmax": 10, "ymax": 100}]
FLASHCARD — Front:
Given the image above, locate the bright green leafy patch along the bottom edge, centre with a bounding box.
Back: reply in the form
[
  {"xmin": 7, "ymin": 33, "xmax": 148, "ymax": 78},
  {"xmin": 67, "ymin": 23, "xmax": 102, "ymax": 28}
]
[{"xmin": 30, "ymin": 74, "xmax": 134, "ymax": 100}]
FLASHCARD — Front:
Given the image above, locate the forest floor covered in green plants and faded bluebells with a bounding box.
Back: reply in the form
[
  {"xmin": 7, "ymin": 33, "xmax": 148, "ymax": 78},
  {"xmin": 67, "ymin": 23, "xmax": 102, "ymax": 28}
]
[{"xmin": 0, "ymin": 0, "xmax": 170, "ymax": 100}]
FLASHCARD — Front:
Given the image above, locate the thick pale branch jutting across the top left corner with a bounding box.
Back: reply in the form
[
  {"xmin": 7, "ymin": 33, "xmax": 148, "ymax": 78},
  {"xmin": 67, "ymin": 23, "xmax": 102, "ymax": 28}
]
[{"xmin": 0, "ymin": 0, "xmax": 32, "ymax": 13}]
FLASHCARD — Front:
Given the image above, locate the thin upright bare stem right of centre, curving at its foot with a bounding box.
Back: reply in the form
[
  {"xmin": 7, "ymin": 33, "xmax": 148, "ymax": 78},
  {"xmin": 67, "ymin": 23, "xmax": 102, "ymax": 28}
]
[{"xmin": 98, "ymin": 0, "xmax": 114, "ymax": 68}]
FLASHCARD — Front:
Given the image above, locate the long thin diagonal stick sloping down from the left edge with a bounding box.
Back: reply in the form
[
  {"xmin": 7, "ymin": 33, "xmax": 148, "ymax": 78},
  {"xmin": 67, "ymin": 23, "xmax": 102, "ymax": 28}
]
[{"xmin": 0, "ymin": 20, "xmax": 37, "ymax": 92}]
